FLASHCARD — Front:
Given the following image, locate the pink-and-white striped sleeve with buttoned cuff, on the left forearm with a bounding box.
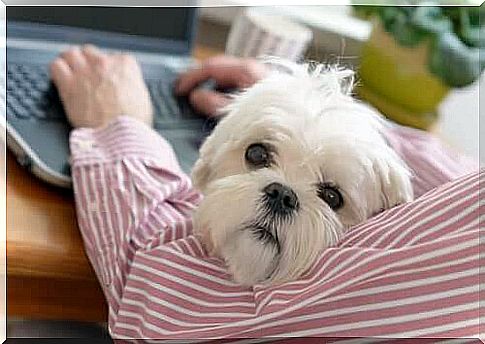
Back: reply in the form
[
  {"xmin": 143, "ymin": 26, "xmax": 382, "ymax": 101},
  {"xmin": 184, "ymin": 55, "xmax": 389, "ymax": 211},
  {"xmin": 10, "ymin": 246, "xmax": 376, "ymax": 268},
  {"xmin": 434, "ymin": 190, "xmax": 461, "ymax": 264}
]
[{"xmin": 70, "ymin": 117, "xmax": 199, "ymax": 326}]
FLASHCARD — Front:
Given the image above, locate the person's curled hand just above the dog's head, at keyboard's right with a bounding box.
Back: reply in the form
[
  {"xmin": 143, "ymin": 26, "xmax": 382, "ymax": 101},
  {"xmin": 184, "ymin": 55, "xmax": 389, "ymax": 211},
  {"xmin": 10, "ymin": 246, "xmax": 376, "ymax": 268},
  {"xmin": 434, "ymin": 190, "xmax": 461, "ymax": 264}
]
[{"xmin": 175, "ymin": 55, "xmax": 267, "ymax": 116}]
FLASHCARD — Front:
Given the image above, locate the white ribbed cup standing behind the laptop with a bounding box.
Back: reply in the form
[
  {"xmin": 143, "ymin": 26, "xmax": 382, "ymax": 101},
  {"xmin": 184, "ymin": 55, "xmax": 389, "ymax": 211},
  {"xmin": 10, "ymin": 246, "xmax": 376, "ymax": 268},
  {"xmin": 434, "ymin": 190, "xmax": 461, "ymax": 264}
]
[{"xmin": 226, "ymin": 8, "xmax": 312, "ymax": 61}]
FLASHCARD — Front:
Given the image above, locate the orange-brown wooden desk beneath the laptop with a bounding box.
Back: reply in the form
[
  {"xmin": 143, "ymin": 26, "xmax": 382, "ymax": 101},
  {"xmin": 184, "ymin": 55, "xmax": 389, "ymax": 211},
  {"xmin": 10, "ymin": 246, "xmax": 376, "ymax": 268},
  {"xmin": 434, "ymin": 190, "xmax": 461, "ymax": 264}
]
[{"xmin": 7, "ymin": 47, "xmax": 216, "ymax": 322}]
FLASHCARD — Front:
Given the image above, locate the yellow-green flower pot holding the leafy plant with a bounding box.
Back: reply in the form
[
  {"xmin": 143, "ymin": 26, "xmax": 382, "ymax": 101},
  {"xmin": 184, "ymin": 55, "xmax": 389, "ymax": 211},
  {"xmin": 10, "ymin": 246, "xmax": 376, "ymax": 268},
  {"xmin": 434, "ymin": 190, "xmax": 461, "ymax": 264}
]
[{"xmin": 356, "ymin": 22, "xmax": 449, "ymax": 129}]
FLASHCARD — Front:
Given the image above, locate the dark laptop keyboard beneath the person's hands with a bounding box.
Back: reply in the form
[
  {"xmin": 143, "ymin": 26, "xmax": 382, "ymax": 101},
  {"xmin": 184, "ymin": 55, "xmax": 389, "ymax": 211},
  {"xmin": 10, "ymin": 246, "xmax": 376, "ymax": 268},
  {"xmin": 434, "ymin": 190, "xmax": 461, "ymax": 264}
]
[{"xmin": 7, "ymin": 63, "xmax": 199, "ymax": 127}]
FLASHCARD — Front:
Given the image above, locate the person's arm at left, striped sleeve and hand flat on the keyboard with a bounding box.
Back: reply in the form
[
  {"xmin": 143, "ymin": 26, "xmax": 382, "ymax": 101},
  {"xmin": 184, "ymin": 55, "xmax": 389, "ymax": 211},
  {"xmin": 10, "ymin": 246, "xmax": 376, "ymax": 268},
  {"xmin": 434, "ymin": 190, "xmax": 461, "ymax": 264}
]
[{"xmin": 51, "ymin": 47, "xmax": 200, "ymax": 323}]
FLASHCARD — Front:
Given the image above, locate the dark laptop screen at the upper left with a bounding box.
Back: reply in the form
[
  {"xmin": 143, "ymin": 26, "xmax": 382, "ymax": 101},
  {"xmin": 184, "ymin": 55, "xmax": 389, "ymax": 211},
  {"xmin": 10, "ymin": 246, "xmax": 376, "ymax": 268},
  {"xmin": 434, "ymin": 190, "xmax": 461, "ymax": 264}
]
[{"xmin": 7, "ymin": 6, "xmax": 195, "ymax": 53}]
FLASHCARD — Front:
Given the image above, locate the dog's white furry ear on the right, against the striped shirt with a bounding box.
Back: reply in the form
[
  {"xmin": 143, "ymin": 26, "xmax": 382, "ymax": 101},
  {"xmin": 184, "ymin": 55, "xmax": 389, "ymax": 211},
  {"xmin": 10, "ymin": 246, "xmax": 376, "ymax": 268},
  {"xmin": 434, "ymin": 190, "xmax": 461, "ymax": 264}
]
[{"xmin": 374, "ymin": 149, "xmax": 413, "ymax": 209}]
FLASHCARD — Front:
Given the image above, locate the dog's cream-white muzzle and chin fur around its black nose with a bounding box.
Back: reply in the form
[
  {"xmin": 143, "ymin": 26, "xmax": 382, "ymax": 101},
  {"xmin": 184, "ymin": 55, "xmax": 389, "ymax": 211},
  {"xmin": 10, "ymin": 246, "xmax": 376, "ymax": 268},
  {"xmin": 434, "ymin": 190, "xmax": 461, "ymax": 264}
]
[{"xmin": 194, "ymin": 174, "xmax": 342, "ymax": 286}]
